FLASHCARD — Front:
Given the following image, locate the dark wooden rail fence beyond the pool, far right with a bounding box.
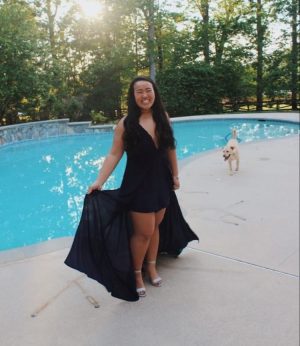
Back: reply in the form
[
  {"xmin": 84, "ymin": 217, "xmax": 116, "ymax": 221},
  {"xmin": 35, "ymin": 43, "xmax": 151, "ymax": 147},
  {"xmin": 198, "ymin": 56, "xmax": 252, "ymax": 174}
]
[{"xmin": 221, "ymin": 99, "xmax": 300, "ymax": 113}]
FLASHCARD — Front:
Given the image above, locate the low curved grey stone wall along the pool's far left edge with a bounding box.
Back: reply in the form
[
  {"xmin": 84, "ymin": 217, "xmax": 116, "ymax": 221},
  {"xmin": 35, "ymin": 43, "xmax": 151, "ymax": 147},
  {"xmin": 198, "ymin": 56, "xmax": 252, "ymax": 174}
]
[{"xmin": 0, "ymin": 119, "xmax": 113, "ymax": 146}]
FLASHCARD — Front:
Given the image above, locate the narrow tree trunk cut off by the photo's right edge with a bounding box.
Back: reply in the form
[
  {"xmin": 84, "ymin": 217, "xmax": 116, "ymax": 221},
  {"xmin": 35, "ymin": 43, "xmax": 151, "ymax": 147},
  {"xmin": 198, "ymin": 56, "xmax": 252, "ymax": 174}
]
[{"xmin": 291, "ymin": 0, "xmax": 299, "ymax": 111}]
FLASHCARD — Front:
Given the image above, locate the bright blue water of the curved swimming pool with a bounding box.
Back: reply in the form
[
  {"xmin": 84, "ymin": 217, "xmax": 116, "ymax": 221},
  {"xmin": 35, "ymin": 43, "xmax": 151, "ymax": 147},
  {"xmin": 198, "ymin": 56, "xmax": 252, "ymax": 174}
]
[{"xmin": 0, "ymin": 119, "xmax": 299, "ymax": 250}]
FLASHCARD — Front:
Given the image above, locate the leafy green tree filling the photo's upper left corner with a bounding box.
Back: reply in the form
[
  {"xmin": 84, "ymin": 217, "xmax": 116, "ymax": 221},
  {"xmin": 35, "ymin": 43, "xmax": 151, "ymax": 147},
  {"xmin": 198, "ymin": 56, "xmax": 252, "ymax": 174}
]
[{"xmin": 0, "ymin": 1, "xmax": 44, "ymax": 124}]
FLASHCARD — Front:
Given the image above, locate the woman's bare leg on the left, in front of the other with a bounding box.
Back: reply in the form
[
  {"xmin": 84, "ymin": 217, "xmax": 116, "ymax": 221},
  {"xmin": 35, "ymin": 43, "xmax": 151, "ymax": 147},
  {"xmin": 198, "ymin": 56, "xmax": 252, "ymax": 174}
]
[{"xmin": 130, "ymin": 211, "xmax": 155, "ymax": 288}]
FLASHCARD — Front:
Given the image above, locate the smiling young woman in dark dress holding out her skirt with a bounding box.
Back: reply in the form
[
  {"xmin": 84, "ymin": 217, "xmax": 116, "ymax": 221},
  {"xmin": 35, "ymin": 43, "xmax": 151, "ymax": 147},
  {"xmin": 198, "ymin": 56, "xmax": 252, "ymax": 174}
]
[{"xmin": 66, "ymin": 77, "xmax": 198, "ymax": 301}]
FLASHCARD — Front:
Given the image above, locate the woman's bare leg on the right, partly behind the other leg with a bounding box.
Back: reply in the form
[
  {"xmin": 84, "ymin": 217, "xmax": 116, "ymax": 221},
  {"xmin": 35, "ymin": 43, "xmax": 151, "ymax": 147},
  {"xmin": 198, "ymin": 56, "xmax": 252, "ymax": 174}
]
[{"xmin": 146, "ymin": 209, "xmax": 166, "ymax": 281}]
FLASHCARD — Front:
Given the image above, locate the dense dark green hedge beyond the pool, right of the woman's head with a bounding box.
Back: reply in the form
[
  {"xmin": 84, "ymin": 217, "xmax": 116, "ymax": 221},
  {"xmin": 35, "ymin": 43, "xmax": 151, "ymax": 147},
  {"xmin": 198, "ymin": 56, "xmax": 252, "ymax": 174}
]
[{"xmin": 158, "ymin": 62, "xmax": 253, "ymax": 116}]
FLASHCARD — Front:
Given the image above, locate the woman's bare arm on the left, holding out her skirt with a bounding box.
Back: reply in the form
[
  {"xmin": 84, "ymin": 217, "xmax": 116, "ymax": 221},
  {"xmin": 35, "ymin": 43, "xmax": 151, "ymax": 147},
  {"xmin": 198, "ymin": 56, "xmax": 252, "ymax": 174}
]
[{"xmin": 88, "ymin": 118, "xmax": 124, "ymax": 193}]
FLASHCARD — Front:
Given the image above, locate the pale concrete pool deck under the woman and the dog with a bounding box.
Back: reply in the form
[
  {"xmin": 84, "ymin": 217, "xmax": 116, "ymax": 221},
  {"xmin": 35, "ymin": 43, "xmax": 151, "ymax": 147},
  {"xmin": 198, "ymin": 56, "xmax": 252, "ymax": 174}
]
[{"xmin": 0, "ymin": 114, "xmax": 299, "ymax": 346}]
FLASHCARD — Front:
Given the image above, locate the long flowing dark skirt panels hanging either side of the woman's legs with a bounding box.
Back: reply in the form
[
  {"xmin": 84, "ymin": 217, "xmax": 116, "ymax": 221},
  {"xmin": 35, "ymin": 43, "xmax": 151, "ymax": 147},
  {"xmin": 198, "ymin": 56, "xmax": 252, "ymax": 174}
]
[{"xmin": 65, "ymin": 190, "xmax": 199, "ymax": 301}]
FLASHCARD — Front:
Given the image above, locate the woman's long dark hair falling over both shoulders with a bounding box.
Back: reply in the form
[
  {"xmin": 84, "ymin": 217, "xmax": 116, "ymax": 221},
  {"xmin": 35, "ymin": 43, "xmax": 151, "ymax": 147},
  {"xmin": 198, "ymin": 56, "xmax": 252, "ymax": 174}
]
[{"xmin": 123, "ymin": 76, "xmax": 175, "ymax": 150}]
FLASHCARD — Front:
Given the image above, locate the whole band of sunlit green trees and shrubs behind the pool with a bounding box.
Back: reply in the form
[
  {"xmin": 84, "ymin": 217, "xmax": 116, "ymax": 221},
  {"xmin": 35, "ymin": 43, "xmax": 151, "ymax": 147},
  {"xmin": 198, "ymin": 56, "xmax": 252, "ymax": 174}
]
[{"xmin": 0, "ymin": 0, "xmax": 299, "ymax": 124}]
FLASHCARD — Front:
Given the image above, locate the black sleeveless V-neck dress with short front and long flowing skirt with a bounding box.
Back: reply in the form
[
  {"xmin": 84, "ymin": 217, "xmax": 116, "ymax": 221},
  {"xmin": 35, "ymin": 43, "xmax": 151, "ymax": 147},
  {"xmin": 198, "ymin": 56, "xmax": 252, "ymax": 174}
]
[{"xmin": 65, "ymin": 121, "xmax": 199, "ymax": 301}]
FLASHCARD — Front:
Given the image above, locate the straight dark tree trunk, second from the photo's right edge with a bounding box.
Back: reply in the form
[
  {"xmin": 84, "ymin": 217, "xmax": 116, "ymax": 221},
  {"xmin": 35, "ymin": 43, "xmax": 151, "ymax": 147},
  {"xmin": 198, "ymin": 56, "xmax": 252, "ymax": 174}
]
[{"xmin": 256, "ymin": 0, "xmax": 264, "ymax": 112}]
